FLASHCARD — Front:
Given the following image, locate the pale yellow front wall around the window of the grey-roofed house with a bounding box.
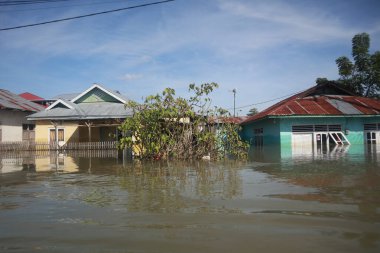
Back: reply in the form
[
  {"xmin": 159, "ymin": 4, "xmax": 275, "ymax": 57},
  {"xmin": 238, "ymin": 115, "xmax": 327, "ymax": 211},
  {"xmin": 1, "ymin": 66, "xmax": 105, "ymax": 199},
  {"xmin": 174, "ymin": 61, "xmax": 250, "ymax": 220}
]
[{"xmin": 36, "ymin": 121, "xmax": 79, "ymax": 143}]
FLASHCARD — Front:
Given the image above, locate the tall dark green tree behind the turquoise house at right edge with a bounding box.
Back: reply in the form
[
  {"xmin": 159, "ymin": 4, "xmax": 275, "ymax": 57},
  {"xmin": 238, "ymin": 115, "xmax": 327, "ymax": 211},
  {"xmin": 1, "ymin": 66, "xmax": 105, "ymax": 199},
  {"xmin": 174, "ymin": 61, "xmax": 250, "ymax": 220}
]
[{"xmin": 336, "ymin": 33, "xmax": 380, "ymax": 97}]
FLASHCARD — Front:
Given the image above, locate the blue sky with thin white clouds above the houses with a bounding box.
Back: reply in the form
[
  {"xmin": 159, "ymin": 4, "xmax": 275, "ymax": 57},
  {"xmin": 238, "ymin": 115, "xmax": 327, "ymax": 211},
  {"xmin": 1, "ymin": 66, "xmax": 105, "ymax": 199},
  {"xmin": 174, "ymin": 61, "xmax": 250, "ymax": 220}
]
[{"xmin": 0, "ymin": 0, "xmax": 380, "ymax": 115}]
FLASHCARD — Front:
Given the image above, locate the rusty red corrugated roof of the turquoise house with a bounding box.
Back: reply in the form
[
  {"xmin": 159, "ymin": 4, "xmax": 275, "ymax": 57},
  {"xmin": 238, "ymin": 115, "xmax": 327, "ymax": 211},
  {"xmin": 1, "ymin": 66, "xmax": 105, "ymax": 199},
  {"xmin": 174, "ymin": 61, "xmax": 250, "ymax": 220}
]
[{"xmin": 242, "ymin": 84, "xmax": 380, "ymax": 124}]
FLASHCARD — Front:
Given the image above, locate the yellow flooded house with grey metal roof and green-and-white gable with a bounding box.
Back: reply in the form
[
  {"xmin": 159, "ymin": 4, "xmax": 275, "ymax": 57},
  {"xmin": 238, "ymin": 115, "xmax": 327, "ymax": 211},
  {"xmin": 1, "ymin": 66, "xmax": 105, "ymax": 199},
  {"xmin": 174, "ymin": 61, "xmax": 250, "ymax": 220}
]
[{"xmin": 28, "ymin": 84, "xmax": 132, "ymax": 146}]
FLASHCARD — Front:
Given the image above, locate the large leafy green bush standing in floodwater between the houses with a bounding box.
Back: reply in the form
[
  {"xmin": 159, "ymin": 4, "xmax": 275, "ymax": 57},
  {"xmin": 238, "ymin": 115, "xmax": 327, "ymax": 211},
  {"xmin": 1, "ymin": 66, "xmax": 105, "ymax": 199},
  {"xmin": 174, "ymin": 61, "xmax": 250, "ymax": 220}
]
[{"xmin": 119, "ymin": 83, "xmax": 248, "ymax": 160}]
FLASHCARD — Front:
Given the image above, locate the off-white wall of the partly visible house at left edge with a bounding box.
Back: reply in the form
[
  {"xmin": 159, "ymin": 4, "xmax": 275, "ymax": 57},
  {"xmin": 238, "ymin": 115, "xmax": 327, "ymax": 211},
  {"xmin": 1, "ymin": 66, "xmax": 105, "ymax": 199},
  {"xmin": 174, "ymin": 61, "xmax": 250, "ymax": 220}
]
[{"xmin": 0, "ymin": 110, "xmax": 31, "ymax": 142}]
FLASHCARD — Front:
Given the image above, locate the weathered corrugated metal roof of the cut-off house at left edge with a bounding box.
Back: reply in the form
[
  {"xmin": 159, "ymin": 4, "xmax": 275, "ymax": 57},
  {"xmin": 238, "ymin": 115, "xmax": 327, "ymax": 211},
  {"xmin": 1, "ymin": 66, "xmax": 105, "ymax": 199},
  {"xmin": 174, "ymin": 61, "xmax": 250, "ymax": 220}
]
[{"xmin": 0, "ymin": 89, "xmax": 45, "ymax": 112}]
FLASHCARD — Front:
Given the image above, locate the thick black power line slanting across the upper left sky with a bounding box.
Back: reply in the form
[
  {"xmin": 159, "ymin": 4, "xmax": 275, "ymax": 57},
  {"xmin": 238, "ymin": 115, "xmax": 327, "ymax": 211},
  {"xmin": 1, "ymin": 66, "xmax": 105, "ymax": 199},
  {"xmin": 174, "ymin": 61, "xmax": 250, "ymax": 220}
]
[{"xmin": 0, "ymin": 0, "xmax": 175, "ymax": 31}]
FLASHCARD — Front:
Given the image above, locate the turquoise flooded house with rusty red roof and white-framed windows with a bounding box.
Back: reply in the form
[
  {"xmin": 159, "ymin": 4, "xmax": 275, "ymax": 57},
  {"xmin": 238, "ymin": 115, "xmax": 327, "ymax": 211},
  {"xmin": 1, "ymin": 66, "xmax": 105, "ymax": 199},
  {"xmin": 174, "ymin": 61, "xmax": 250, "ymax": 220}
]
[{"xmin": 241, "ymin": 84, "xmax": 380, "ymax": 154}]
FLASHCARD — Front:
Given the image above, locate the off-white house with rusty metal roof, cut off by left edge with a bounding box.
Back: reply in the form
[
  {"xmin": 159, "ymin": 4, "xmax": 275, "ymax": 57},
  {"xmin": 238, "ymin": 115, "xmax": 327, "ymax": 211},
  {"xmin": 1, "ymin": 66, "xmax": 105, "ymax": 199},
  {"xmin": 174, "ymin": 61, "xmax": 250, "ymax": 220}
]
[{"xmin": 0, "ymin": 89, "xmax": 45, "ymax": 143}]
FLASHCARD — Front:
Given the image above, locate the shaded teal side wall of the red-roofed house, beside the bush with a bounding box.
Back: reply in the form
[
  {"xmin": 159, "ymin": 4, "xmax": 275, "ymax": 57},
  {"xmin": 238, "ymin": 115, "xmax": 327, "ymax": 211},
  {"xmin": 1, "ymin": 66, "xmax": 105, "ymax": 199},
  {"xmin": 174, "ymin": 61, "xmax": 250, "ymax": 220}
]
[{"xmin": 241, "ymin": 119, "xmax": 280, "ymax": 145}]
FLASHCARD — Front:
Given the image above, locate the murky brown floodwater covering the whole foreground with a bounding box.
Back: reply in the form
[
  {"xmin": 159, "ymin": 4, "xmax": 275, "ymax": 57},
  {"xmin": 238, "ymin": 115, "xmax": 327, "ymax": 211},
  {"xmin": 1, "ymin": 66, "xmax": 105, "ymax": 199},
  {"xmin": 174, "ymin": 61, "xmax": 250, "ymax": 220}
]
[{"xmin": 0, "ymin": 149, "xmax": 380, "ymax": 252}]
